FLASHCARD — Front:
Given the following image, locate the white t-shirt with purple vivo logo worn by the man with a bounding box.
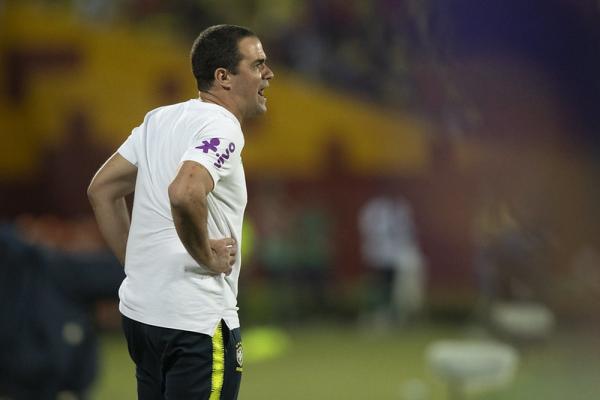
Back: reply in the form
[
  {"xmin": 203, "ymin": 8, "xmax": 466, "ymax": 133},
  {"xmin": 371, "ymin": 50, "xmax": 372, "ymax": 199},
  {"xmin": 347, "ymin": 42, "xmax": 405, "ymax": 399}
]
[{"xmin": 118, "ymin": 99, "xmax": 247, "ymax": 336}]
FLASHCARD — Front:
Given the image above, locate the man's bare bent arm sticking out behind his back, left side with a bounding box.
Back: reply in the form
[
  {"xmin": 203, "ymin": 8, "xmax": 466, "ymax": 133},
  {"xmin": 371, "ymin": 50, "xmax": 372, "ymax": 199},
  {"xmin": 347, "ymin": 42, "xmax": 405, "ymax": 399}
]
[{"xmin": 87, "ymin": 153, "xmax": 137, "ymax": 265}]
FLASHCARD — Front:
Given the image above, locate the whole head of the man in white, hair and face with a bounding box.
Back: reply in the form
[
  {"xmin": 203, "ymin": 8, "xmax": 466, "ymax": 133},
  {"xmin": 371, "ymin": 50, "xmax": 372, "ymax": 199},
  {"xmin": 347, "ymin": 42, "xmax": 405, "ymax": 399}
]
[{"xmin": 191, "ymin": 25, "xmax": 273, "ymax": 118}]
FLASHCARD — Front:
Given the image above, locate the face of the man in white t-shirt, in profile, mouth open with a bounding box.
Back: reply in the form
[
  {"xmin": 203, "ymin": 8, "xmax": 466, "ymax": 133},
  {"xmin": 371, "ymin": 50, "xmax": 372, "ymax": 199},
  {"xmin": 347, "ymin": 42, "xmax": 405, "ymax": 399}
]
[{"xmin": 231, "ymin": 37, "xmax": 274, "ymax": 117}]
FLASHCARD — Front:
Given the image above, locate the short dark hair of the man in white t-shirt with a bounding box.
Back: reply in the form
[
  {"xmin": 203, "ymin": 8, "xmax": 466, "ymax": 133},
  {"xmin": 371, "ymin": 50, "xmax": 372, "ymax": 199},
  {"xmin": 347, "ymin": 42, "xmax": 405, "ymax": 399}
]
[{"xmin": 190, "ymin": 25, "xmax": 256, "ymax": 91}]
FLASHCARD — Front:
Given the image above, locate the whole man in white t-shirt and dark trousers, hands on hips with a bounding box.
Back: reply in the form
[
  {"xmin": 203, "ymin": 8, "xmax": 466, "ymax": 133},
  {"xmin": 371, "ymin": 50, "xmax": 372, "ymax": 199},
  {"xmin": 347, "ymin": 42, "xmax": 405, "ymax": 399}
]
[{"xmin": 88, "ymin": 25, "xmax": 273, "ymax": 400}]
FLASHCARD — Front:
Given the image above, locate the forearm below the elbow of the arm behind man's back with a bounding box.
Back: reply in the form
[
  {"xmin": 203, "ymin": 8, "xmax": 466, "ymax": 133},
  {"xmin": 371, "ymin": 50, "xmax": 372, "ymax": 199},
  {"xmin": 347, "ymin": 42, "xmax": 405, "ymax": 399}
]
[{"xmin": 91, "ymin": 197, "xmax": 131, "ymax": 265}]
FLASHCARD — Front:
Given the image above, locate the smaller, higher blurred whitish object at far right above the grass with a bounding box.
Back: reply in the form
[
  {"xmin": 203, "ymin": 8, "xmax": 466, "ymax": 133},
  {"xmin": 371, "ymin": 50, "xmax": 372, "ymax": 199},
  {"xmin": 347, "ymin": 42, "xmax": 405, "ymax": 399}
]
[{"xmin": 490, "ymin": 302, "xmax": 555, "ymax": 340}]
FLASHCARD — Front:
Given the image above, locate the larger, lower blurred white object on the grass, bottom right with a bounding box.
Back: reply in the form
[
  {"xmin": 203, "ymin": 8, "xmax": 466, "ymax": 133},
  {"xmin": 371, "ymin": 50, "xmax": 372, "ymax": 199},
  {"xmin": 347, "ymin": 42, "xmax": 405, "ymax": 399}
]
[{"xmin": 426, "ymin": 340, "xmax": 519, "ymax": 399}]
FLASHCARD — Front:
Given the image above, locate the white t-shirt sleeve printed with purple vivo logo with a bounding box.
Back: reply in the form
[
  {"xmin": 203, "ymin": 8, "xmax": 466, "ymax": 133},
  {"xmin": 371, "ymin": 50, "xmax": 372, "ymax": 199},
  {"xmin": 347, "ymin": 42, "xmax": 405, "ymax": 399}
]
[{"xmin": 181, "ymin": 120, "xmax": 244, "ymax": 187}]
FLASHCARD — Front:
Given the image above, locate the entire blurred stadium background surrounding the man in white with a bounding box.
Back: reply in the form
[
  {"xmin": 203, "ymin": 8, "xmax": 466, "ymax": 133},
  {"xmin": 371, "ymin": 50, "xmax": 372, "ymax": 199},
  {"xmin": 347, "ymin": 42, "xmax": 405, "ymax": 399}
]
[{"xmin": 0, "ymin": 0, "xmax": 600, "ymax": 400}]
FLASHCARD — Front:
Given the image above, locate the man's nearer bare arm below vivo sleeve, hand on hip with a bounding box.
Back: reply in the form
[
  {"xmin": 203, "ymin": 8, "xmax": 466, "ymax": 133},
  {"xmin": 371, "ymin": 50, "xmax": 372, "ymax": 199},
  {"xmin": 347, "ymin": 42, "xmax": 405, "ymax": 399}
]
[{"xmin": 169, "ymin": 161, "xmax": 237, "ymax": 274}]
